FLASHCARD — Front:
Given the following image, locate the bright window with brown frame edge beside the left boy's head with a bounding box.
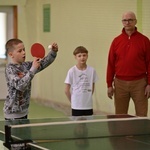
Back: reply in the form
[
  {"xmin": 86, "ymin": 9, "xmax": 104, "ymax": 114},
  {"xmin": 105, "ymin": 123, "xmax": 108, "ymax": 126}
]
[{"xmin": 0, "ymin": 6, "xmax": 17, "ymax": 62}]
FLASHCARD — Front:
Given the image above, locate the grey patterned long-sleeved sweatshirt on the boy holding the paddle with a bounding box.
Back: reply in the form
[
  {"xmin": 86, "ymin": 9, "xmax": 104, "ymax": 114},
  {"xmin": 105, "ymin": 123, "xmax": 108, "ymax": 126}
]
[{"xmin": 3, "ymin": 51, "xmax": 57, "ymax": 119}]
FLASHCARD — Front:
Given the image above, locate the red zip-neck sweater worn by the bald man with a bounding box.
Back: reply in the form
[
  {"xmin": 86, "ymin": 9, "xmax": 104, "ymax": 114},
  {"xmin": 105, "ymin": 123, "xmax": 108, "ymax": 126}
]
[{"xmin": 107, "ymin": 28, "xmax": 150, "ymax": 87}]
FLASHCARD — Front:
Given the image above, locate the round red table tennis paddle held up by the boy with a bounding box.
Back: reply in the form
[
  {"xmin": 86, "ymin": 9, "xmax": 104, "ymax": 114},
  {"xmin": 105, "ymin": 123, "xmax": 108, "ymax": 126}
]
[{"xmin": 31, "ymin": 43, "xmax": 45, "ymax": 58}]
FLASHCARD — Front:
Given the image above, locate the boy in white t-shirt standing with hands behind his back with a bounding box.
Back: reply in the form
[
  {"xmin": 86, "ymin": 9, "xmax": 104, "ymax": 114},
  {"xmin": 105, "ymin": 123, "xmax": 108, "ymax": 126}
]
[{"xmin": 65, "ymin": 46, "xmax": 98, "ymax": 116}]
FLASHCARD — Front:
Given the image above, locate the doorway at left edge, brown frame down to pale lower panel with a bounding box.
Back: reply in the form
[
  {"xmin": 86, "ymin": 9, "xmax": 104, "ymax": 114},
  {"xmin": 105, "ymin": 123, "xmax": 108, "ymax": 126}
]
[{"xmin": 0, "ymin": 6, "xmax": 17, "ymax": 100}]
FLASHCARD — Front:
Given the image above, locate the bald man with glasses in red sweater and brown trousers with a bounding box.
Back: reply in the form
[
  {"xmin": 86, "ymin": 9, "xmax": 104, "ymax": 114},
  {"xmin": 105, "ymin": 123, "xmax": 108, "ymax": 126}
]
[{"xmin": 107, "ymin": 12, "xmax": 150, "ymax": 116}]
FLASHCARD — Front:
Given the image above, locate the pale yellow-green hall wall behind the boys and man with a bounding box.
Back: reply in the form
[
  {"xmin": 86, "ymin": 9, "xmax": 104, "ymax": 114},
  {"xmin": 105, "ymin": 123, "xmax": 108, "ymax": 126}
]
[{"xmin": 0, "ymin": 0, "xmax": 150, "ymax": 115}]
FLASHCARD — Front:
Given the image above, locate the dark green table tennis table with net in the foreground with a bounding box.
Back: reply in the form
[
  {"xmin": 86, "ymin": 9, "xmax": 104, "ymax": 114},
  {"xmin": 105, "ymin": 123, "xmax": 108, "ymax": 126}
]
[{"xmin": 0, "ymin": 115, "xmax": 150, "ymax": 150}]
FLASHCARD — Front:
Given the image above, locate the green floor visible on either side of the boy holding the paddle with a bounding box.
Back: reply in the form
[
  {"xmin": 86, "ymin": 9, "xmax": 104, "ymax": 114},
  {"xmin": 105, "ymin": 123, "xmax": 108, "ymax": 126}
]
[{"xmin": 0, "ymin": 100, "xmax": 65, "ymax": 120}]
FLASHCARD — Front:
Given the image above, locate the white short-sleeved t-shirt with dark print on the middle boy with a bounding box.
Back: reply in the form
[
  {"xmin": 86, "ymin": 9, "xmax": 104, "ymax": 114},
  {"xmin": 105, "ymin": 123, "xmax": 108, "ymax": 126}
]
[{"xmin": 65, "ymin": 66, "xmax": 98, "ymax": 110}]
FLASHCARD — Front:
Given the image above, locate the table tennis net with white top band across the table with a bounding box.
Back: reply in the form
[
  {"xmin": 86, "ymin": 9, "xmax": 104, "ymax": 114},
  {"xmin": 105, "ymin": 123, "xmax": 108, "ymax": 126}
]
[{"xmin": 4, "ymin": 118, "xmax": 150, "ymax": 142}]
